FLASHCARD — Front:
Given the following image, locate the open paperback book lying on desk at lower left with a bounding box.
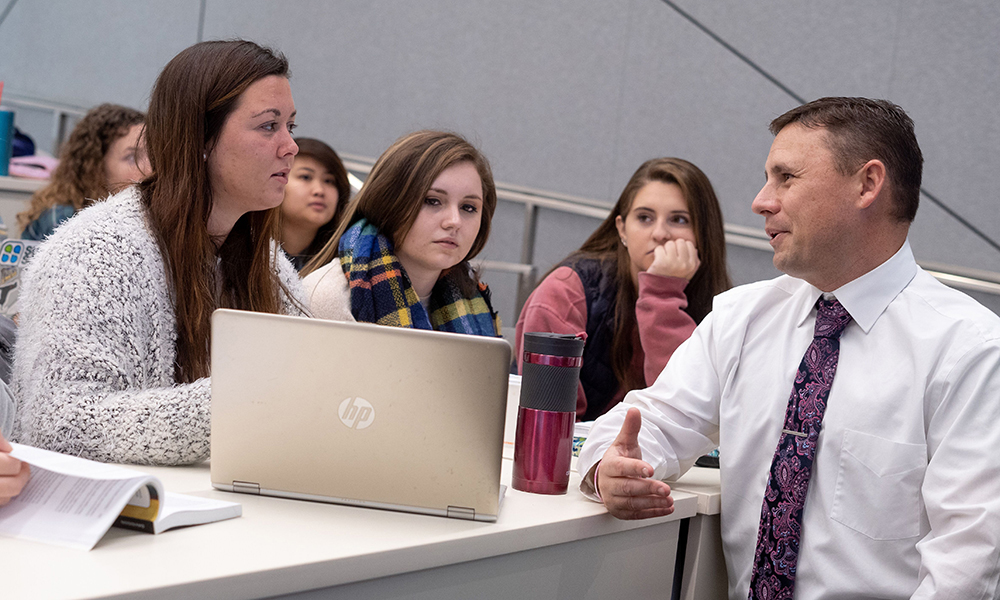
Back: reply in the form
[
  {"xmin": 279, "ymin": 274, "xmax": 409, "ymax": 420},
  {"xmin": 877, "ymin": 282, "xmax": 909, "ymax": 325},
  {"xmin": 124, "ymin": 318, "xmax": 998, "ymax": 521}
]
[{"xmin": 0, "ymin": 444, "xmax": 243, "ymax": 550}]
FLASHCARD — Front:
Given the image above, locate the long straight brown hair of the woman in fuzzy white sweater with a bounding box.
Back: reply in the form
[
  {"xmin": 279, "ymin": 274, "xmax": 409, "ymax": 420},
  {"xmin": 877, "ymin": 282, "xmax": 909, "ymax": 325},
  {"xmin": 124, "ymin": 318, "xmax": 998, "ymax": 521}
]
[{"xmin": 140, "ymin": 40, "xmax": 291, "ymax": 382}]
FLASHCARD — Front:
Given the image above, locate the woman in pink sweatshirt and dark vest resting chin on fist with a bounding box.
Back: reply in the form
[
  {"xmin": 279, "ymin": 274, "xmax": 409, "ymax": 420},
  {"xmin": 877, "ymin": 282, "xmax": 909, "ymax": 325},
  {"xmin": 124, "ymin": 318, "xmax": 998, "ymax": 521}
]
[{"xmin": 515, "ymin": 158, "xmax": 732, "ymax": 421}]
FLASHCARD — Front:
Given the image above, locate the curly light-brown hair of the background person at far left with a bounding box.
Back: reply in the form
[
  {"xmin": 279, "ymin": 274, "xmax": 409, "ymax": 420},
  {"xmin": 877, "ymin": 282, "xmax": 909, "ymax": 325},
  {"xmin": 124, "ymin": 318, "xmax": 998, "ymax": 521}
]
[{"xmin": 17, "ymin": 104, "xmax": 146, "ymax": 228}]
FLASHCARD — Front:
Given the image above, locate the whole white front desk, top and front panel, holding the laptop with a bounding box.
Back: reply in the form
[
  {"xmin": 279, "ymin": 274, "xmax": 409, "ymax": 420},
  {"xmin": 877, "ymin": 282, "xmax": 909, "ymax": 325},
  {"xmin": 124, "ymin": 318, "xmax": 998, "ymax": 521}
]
[{"xmin": 0, "ymin": 460, "xmax": 697, "ymax": 600}]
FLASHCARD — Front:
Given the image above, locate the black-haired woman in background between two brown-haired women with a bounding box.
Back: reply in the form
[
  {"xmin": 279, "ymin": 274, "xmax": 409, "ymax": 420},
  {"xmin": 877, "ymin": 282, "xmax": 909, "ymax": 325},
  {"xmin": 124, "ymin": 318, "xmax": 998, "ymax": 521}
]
[{"xmin": 281, "ymin": 138, "xmax": 351, "ymax": 271}]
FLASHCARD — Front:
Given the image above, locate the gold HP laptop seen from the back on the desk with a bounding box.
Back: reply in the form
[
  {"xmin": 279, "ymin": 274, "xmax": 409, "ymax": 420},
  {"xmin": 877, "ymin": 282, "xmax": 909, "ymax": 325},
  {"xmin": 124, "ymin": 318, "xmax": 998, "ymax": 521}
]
[{"xmin": 212, "ymin": 310, "xmax": 511, "ymax": 521}]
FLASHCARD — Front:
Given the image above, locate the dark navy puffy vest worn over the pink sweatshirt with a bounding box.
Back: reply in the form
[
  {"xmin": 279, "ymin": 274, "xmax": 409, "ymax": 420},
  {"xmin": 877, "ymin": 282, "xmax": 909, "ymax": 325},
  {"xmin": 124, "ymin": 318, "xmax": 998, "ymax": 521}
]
[{"xmin": 560, "ymin": 258, "xmax": 619, "ymax": 421}]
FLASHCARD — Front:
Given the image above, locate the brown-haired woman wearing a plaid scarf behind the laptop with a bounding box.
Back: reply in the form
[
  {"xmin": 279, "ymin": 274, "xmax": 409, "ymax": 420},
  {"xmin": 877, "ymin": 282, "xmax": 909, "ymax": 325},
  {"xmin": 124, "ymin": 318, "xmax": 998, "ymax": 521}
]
[{"xmin": 303, "ymin": 131, "xmax": 500, "ymax": 336}]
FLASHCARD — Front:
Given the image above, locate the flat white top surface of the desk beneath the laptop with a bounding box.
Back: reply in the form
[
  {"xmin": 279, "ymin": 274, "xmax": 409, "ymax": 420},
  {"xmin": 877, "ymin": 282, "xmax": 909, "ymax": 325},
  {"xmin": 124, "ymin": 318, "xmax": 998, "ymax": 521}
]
[{"xmin": 0, "ymin": 461, "xmax": 698, "ymax": 600}]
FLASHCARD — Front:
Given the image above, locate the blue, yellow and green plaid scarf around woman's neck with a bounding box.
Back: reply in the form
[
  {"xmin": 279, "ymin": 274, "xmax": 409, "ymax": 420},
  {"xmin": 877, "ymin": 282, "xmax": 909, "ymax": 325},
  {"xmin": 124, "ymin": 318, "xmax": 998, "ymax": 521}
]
[{"xmin": 338, "ymin": 219, "xmax": 500, "ymax": 337}]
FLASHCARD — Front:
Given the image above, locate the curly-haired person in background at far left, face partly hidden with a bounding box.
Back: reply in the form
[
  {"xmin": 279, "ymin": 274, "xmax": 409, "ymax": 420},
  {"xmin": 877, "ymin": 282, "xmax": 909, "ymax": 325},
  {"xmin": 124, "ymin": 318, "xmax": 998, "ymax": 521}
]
[{"xmin": 17, "ymin": 104, "xmax": 149, "ymax": 240}]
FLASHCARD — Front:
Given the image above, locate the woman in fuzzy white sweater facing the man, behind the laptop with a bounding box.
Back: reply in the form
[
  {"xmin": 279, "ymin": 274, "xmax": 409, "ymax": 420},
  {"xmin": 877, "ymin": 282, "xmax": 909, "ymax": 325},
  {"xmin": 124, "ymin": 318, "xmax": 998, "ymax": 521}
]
[{"xmin": 13, "ymin": 41, "xmax": 301, "ymax": 464}]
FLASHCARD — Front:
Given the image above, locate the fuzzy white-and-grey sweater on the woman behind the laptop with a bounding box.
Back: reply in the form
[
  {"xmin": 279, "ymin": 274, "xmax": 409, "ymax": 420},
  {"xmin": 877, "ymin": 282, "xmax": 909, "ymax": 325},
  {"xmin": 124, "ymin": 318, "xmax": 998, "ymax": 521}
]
[{"xmin": 12, "ymin": 188, "xmax": 302, "ymax": 465}]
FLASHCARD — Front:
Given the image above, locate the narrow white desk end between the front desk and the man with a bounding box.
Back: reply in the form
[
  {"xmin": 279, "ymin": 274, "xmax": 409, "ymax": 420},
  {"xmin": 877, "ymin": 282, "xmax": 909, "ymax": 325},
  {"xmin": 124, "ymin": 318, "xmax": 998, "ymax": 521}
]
[{"xmin": 669, "ymin": 467, "xmax": 729, "ymax": 600}]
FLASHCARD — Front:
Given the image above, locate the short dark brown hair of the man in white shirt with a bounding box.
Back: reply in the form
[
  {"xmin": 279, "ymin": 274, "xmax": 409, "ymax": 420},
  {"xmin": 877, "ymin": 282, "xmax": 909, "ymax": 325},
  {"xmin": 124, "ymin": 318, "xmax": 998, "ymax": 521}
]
[{"xmin": 771, "ymin": 98, "xmax": 924, "ymax": 222}]
